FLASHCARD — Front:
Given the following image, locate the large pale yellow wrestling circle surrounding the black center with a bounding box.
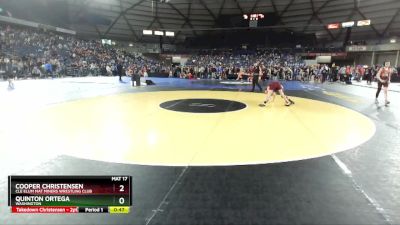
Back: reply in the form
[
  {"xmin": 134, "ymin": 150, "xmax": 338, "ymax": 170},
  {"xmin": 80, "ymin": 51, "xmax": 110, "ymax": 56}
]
[{"xmin": 0, "ymin": 91, "xmax": 375, "ymax": 166}]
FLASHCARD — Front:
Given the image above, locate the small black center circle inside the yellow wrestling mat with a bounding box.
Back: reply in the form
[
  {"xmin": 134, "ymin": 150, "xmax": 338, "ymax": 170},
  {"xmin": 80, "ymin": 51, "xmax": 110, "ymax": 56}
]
[{"xmin": 160, "ymin": 98, "xmax": 246, "ymax": 113}]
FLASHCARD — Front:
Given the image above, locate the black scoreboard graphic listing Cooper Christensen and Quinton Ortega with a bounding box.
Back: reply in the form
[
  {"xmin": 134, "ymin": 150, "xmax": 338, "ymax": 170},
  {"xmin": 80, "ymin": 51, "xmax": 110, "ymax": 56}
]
[{"xmin": 8, "ymin": 175, "xmax": 132, "ymax": 213}]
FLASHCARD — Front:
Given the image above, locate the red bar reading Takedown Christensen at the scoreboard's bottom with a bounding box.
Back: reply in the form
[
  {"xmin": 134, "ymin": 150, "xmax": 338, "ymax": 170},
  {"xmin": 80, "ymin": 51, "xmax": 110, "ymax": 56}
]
[{"xmin": 11, "ymin": 206, "xmax": 78, "ymax": 214}]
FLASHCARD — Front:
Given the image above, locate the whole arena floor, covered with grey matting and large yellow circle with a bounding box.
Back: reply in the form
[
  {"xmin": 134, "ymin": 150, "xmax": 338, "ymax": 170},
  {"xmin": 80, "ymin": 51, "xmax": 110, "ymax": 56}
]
[{"xmin": 0, "ymin": 77, "xmax": 400, "ymax": 225}]
